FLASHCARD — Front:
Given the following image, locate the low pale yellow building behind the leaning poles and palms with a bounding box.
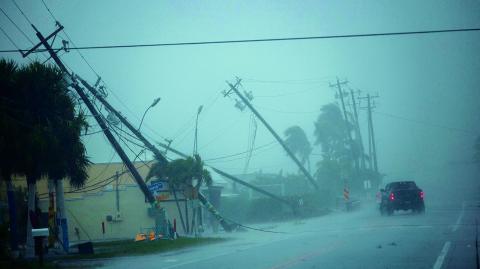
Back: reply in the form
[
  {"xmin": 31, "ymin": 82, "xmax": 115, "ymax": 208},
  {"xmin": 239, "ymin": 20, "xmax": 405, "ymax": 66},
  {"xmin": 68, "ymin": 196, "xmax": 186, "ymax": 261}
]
[{"xmin": 6, "ymin": 162, "xmax": 194, "ymax": 243}]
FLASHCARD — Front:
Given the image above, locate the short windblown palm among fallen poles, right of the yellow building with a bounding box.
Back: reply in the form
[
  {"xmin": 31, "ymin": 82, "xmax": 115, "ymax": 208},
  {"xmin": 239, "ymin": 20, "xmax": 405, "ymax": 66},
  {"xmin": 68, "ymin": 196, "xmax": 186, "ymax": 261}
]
[{"xmin": 147, "ymin": 155, "xmax": 212, "ymax": 232}]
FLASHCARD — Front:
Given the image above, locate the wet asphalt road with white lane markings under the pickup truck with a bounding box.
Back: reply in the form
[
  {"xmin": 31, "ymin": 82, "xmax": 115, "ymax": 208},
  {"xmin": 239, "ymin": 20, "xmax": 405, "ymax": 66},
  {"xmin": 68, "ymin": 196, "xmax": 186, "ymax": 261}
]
[{"xmin": 79, "ymin": 173, "xmax": 480, "ymax": 269}]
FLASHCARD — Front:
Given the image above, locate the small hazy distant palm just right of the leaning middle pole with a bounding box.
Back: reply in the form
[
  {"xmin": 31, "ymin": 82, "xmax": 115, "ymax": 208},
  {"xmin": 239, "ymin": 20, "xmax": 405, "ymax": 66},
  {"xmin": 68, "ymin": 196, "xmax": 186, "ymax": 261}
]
[{"xmin": 284, "ymin": 125, "xmax": 312, "ymax": 171}]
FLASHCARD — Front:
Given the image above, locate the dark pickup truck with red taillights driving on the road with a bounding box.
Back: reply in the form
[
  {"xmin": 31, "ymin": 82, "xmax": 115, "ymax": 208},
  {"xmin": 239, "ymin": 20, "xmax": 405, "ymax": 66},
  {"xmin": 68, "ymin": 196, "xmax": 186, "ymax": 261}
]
[{"xmin": 380, "ymin": 181, "xmax": 425, "ymax": 215}]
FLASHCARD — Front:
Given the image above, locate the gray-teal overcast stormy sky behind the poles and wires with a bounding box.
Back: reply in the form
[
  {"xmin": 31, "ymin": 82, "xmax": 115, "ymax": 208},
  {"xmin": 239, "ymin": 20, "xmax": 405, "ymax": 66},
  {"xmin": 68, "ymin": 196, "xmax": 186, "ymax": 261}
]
[{"xmin": 0, "ymin": 0, "xmax": 480, "ymax": 181}]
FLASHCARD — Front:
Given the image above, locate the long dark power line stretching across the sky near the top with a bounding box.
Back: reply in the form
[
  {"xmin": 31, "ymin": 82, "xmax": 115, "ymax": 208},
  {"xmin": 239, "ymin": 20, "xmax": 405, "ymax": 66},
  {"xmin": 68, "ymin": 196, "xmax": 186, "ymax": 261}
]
[{"xmin": 0, "ymin": 26, "xmax": 480, "ymax": 53}]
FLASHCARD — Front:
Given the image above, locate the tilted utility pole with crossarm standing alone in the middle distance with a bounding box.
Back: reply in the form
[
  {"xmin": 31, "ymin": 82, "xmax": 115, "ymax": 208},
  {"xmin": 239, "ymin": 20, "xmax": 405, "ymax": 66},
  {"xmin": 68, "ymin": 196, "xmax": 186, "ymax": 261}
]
[{"xmin": 225, "ymin": 78, "xmax": 319, "ymax": 190}]
